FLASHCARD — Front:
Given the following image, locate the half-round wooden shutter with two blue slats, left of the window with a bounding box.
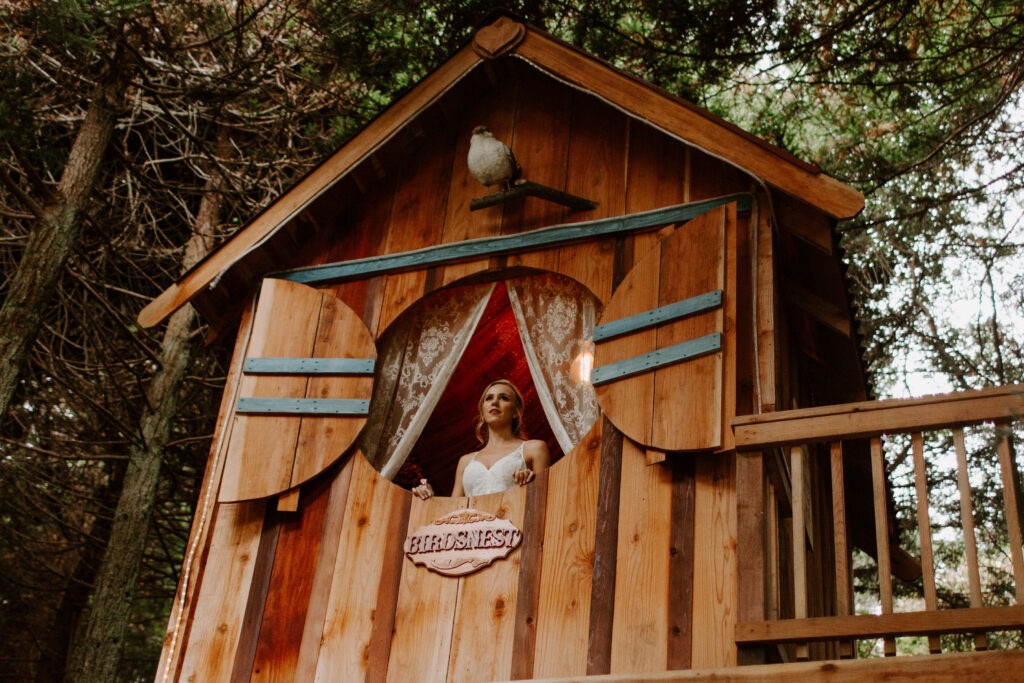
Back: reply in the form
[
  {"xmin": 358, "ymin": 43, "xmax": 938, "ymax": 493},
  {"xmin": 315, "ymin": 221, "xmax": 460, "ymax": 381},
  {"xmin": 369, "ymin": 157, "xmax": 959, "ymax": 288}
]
[{"xmin": 219, "ymin": 279, "xmax": 377, "ymax": 502}]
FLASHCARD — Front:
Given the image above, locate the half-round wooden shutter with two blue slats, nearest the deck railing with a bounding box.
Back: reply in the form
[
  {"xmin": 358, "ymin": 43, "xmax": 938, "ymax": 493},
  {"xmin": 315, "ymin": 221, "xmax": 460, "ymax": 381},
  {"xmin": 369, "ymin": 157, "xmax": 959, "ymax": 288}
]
[{"xmin": 591, "ymin": 207, "xmax": 728, "ymax": 451}]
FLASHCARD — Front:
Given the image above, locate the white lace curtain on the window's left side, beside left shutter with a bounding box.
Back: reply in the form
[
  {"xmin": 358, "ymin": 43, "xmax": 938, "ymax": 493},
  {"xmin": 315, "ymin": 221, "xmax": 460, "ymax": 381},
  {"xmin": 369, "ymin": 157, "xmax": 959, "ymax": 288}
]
[{"xmin": 360, "ymin": 285, "xmax": 495, "ymax": 479}]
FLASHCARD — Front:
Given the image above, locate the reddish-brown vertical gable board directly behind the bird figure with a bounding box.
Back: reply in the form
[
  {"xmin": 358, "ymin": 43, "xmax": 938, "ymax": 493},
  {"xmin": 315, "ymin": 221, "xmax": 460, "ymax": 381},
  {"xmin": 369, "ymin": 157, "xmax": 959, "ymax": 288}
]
[{"xmin": 440, "ymin": 74, "xmax": 518, "ymax": 286}]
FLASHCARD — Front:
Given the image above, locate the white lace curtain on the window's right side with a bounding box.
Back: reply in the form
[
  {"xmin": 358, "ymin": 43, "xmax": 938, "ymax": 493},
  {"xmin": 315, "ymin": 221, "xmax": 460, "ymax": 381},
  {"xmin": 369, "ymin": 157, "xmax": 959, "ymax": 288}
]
[{"xmin": 507, "ymin": 274, "xmax": 599, "ymax": 453}]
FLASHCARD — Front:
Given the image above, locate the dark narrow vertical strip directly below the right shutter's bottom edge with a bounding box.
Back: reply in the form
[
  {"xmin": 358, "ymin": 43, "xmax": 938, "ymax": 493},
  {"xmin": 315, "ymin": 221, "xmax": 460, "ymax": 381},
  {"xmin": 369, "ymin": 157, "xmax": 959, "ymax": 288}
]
[{"xmin": 667, "ymin": 457, "xmax": 696, "ymax": 670}]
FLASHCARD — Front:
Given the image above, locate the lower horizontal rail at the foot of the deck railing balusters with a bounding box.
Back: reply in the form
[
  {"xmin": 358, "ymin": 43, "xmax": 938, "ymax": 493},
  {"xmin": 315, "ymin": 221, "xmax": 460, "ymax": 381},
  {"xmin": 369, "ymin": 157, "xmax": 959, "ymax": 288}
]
[{"xmin": 736, "ymin": 605, "xmax": 1024, "ymax": 645}]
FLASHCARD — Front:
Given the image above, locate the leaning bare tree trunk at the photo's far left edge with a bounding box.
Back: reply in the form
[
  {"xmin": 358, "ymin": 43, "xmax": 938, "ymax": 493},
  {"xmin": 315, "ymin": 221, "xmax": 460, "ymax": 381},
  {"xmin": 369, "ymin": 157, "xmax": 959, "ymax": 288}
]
[{"xmin": 0, "ymin": 65, "xmax": 129, "ymax": 424}]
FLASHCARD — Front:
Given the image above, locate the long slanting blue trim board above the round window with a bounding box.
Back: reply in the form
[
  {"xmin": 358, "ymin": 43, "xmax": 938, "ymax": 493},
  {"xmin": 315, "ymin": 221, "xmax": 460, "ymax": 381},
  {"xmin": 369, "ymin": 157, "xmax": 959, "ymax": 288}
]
[{"xmin": 267, "ymin": 193, "xmax": 751, "ymax": 285}]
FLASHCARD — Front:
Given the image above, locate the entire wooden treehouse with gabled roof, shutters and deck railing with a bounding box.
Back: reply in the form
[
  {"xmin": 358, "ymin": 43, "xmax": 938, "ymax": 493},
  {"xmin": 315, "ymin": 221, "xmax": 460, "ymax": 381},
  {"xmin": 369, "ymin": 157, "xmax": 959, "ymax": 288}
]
[{"xmin": 139, "ymin": 17, "xmax": 1024, "ymax": 681}]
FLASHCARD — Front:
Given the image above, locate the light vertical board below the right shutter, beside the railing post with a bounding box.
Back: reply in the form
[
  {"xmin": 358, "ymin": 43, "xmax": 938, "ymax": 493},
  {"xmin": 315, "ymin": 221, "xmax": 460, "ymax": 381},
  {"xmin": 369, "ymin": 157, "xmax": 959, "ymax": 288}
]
[{"xmin": 692, "ymin": 454, "xmax": 736, "ymax": 669}]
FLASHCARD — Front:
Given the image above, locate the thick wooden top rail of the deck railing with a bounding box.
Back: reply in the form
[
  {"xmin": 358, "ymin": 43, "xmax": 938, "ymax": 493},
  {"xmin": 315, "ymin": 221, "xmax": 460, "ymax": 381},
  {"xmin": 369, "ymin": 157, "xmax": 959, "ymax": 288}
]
[{"xmin": 731, "ymin": 384, "xmax": 1024, "ymax": 449}]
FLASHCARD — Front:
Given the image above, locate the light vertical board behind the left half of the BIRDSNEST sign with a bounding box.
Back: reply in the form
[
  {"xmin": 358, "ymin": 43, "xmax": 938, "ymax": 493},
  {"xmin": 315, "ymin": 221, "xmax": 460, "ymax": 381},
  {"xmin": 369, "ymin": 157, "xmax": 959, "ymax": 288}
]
[{"xmin": 387, "ymin": 498, "xmax": 467, "ymax": 683}]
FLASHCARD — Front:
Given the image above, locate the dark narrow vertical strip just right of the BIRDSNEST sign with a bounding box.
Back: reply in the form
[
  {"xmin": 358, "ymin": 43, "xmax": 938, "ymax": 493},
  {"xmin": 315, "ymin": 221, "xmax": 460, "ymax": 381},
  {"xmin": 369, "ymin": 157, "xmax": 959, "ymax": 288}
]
[{"xmin": 509, "ymin": 469, "xmax": 551, "ymax": 680}]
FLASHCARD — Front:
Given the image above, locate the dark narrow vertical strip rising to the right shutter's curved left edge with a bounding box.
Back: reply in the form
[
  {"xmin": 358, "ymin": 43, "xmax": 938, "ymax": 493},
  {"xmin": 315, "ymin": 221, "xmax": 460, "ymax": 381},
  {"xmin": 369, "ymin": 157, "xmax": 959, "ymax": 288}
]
[{"xmin": 587, "ymin": 418, "xmax": 625, "ymax": 675}]
